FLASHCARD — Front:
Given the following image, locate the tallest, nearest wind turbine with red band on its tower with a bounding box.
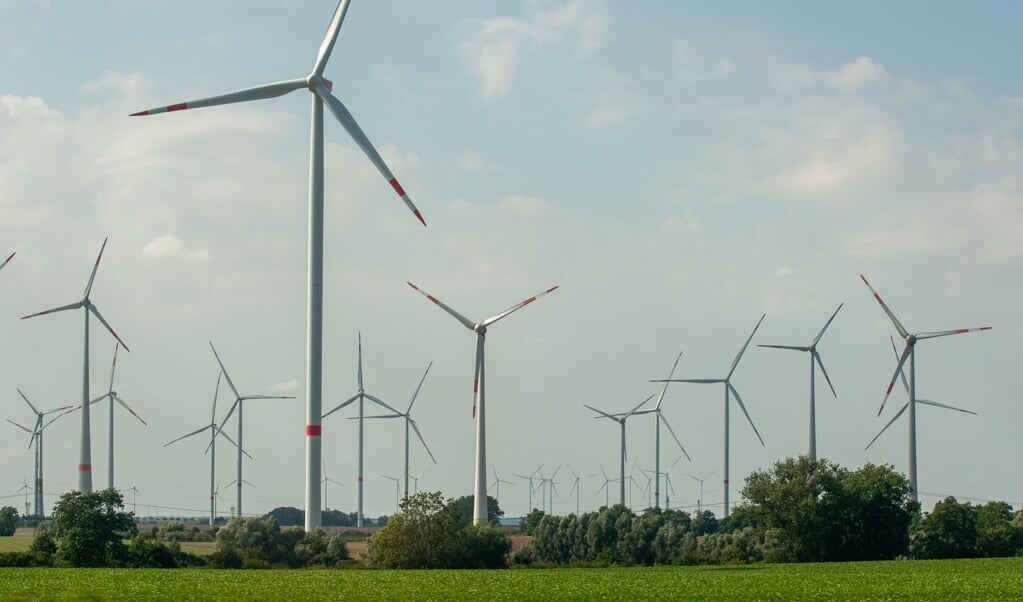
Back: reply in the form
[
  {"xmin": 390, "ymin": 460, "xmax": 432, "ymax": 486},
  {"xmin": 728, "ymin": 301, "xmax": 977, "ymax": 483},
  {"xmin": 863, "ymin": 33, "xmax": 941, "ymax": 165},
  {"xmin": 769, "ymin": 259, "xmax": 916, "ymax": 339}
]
[{"xmin": 132, "ymin": 0, "xmax": 427, "ymax": 531}]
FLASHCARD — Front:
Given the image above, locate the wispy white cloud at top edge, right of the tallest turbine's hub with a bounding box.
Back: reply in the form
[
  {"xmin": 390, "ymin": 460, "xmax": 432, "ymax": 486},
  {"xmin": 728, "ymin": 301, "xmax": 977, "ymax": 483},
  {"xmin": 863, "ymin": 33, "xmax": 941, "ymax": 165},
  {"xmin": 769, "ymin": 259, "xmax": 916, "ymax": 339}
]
[{"xmin": 460, "ymin": 0, "xmax": 609, "ymax": 100}]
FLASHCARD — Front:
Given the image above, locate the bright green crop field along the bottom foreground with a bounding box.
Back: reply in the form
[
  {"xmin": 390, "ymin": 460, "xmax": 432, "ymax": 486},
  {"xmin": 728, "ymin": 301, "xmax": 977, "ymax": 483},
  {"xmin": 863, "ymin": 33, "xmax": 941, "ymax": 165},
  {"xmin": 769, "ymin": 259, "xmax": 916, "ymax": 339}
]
[{"xmin": 0, "ymin": 558, "xmax": 1023, "ymax": 602}]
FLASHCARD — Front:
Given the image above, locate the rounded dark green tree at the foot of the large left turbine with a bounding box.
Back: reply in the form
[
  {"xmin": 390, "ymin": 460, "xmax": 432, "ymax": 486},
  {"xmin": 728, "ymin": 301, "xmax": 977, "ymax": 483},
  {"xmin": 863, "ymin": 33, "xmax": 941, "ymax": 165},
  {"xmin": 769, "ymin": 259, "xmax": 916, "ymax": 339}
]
[{"xmin": 53, "ymin": 489, "xmax": 138, "ymax": 566}]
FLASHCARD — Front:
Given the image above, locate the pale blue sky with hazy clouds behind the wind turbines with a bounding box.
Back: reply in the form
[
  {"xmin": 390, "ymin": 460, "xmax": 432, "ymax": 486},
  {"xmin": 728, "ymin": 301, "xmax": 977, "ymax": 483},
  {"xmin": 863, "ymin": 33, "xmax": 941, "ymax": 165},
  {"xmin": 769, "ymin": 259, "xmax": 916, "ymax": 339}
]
[{"xmin": 0, "ymin": 0, "xmax": 1023, "ymax": 517}]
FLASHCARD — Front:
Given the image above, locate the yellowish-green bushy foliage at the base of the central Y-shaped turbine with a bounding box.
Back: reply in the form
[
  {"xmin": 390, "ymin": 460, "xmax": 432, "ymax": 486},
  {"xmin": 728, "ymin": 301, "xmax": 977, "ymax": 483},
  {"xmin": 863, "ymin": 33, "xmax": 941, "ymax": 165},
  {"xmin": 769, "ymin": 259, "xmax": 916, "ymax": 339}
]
[{"xmin": 368, "ymin": 491, "xmax": 512, "ymax": 568}]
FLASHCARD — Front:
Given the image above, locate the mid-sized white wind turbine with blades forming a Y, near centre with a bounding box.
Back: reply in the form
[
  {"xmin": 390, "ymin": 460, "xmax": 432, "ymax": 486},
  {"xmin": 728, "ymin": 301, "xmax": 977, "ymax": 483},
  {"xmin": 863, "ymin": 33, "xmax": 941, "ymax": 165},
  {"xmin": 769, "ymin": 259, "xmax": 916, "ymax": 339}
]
[{"xmin": 408, "ymin": 283, "xmax": 558, "ymax": 525}]
